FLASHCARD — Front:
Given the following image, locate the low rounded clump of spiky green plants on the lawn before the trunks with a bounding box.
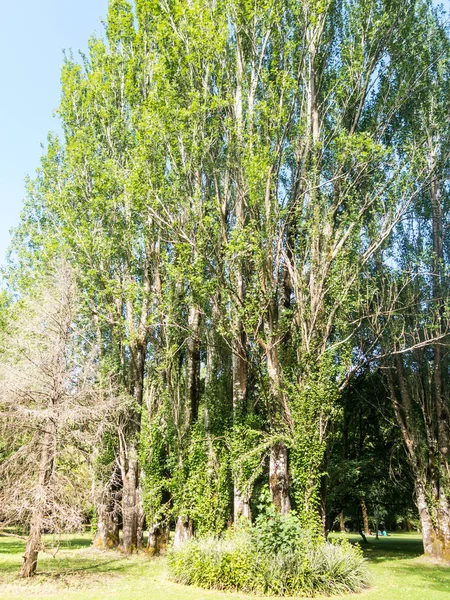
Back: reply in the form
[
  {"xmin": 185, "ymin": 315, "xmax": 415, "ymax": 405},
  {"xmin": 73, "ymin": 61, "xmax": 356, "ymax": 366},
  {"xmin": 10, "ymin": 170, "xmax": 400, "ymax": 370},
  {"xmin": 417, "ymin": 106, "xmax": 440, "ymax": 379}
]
[{"xmin": 168, "ymin": 516, "xmax": 370, "ymax": 596}]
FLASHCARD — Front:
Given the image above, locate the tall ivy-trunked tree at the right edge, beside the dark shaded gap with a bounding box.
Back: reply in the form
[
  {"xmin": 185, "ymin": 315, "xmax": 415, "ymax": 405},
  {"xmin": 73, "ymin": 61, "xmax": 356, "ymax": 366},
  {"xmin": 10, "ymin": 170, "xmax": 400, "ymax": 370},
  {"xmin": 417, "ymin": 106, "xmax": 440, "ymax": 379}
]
[{"xmin": 370, "ymin": 6, "xmax": 450, "ymax": 557}]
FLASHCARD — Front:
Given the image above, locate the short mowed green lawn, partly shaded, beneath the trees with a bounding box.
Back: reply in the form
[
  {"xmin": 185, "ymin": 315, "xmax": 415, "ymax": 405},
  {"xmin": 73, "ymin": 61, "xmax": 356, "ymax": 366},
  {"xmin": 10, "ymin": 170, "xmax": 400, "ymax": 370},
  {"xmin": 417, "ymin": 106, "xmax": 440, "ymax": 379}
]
[{"xmin": 0, "ymin": 534, "xmax": 450, "ymax": 600}]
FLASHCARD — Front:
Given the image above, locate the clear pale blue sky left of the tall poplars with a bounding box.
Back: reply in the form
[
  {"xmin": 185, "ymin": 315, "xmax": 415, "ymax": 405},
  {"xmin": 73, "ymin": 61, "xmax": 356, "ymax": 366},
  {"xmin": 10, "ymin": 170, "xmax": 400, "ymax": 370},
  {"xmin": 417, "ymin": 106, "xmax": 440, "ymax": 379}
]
[{"xmin": 0, "ymin": 0, "xmax": 108, "ymax": 263}]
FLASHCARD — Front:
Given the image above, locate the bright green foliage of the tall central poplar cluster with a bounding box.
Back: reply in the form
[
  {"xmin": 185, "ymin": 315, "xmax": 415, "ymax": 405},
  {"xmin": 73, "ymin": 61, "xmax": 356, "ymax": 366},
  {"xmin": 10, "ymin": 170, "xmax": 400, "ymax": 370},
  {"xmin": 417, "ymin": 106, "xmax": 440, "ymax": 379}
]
[{"xmin": 6, "ymin": 0, "xmax": 450, "ymax": 556}]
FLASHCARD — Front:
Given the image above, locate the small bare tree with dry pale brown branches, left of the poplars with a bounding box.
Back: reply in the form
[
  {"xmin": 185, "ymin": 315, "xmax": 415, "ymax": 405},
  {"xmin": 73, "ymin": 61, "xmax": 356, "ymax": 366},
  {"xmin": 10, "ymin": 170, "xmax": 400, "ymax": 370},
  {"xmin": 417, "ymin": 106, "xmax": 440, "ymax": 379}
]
[{"xmin": 0, "ymin": 265, "xmax": 111, "ymax": 577}]
